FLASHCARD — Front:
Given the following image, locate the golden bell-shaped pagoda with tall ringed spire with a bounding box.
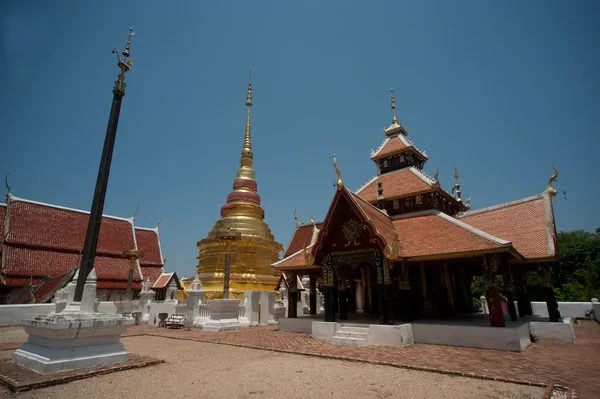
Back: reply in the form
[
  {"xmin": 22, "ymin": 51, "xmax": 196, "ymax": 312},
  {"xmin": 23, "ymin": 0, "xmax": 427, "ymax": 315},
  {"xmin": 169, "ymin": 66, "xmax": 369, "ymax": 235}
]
[{"xmin": 196, "ymin": 70, "xmax": 283, "ymax": 299}]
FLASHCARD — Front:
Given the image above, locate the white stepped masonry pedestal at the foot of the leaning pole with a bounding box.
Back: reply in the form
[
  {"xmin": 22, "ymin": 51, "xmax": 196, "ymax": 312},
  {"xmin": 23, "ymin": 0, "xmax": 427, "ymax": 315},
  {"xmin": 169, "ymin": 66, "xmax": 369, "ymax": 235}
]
[{"xmin": 12, "ymin": 306, "xmax": 134, "ymax": 374}]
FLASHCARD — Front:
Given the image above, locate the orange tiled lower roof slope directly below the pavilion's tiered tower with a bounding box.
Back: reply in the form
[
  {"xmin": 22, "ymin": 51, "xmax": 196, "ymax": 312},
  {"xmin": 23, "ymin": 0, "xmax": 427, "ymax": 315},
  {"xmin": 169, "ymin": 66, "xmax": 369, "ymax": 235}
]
[{"xmin": 393, "ymin": 211, "xmax": 510, "ymax": 258}]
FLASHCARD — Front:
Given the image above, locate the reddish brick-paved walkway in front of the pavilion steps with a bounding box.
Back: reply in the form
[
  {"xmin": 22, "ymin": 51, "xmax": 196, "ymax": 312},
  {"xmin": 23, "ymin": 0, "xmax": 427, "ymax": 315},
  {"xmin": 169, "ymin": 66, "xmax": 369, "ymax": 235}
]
[{"xmin": 124, "ymin": 321, "xmax": 600, "ymax": 398}]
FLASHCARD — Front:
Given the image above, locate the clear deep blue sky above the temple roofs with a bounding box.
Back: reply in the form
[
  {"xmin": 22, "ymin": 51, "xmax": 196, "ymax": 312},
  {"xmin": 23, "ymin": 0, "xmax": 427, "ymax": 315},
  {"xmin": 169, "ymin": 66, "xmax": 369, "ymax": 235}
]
[{"xmin": 0, "ymin": 0, "xmax": 600, "ymax": 275}]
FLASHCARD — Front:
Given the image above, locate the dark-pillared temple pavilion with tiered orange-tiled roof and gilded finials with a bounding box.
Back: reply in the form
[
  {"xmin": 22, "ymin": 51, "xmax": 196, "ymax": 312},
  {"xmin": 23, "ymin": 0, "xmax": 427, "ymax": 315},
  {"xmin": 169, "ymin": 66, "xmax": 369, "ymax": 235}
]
[{"xmin": 273, "ymin": 91, "xmax": 560, "ymax": 327}]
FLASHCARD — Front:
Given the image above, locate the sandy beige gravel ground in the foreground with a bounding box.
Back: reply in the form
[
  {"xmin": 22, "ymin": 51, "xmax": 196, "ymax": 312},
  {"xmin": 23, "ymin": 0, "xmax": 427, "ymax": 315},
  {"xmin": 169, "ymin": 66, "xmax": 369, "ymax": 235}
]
[{"xmin": 0, "ymin": 337, "xmax": 544, "ymax": 399}]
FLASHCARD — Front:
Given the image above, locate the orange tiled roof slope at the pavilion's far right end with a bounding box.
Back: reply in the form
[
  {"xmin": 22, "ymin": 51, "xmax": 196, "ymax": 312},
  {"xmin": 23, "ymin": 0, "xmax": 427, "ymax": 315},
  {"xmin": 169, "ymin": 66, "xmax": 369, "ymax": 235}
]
[{"xmin": 460, "ymin": 194, "xmax": 556, "ymax": 260}]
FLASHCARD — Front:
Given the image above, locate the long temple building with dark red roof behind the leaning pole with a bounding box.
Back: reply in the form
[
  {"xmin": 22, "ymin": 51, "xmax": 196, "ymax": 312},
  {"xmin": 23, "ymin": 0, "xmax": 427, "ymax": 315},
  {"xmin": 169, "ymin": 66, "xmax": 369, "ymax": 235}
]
[{"xmin": 0, "ymin": 192, "xmax": 164, "ymax": 304}]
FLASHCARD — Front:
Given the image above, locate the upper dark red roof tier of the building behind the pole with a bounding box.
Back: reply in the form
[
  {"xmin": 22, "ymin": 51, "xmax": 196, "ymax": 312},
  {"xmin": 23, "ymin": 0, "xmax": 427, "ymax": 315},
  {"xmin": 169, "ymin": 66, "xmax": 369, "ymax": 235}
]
[{"xmin": 6, "ymin": 198, "xmax": 134, "ymax": 256}]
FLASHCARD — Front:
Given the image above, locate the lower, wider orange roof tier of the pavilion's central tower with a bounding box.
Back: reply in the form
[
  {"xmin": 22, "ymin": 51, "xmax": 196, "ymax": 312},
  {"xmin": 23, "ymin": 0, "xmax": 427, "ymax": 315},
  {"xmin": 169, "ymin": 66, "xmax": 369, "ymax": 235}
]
[{"xmin": 356, "ymin": 167, "xmax": 434, "ymax": 202}]
